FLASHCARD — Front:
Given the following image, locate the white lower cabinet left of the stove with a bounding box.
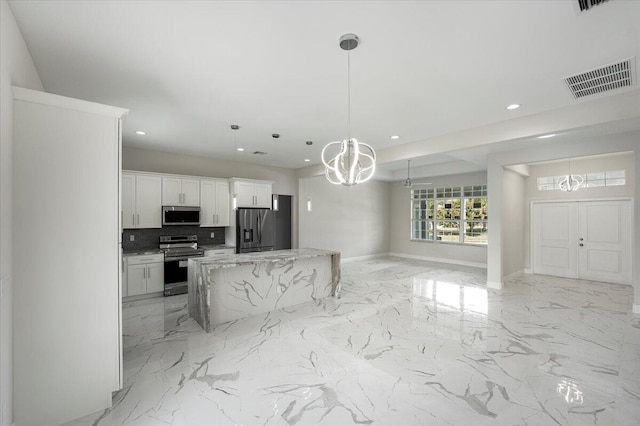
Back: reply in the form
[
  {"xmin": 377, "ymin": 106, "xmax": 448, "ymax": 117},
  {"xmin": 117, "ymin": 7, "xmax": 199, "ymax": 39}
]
[{"xmin": 127, "ymin": 254, "xmax": 164, "ymax": 296}]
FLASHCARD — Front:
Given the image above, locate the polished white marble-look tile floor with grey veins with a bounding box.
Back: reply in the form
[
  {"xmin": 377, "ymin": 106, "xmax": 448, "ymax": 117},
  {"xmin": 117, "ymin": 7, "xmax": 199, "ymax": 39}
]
[{"xmin": 71, "ymin": 258, "xmax": 640, "ymax": 426}]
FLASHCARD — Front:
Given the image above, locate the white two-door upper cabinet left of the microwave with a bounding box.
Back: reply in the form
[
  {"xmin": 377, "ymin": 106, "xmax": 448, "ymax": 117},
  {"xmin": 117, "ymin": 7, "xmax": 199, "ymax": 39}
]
[{"xmin": 121, "ymin": 173, "xmax": 163, "ymax": 229}]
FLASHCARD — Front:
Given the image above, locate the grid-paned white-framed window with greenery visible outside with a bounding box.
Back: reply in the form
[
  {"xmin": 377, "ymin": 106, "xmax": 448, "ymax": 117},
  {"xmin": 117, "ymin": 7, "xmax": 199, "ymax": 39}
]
[{"xmin": 411, "ymin": 185, "xmax": 488, "ymax": 244}]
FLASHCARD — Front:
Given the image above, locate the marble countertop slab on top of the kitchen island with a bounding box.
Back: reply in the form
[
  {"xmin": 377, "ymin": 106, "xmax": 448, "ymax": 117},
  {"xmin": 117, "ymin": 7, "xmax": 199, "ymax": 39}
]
[{"xmin": 189, "ymin": 248, "xmax": 340, "ymax": 268}]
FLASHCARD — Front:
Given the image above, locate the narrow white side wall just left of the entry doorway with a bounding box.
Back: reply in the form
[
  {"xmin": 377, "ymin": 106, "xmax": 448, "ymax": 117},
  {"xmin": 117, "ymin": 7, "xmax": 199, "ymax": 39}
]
[{"xmin": 502, "ymin": 169, "xmax": 527, "ymax": 276}]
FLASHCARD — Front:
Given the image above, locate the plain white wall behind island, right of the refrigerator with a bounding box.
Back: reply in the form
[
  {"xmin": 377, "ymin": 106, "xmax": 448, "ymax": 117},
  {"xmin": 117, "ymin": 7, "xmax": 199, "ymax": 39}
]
[{"xmin": 298, "ymin": 176, "xmax": 389, "ymax": 260}]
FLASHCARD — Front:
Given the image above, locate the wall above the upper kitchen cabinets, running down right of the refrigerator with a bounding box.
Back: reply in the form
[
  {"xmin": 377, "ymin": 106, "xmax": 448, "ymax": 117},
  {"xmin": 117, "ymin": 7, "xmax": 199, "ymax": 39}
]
[{"xmin": 122, "ymin": 147, "xmax": 298, "ymax": 247}]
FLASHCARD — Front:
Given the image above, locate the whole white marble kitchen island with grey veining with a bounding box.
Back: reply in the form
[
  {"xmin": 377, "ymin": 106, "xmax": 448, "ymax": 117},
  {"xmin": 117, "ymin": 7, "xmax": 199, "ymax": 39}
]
[{"xmin": 188, "ymin": 249, "xmax": 340, "ymax": 332}]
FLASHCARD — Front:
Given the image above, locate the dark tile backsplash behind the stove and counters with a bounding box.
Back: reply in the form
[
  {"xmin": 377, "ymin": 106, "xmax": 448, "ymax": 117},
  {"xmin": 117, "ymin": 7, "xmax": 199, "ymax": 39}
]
[{"xmin": 122, "ymin": 226, "xmax": 225, "ymax": 252}]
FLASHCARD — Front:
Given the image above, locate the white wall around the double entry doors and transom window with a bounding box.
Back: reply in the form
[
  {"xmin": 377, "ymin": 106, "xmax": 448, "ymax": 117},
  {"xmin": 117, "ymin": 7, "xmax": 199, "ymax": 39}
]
[{"xmin": 524, "ymin": 152, "xmax": 640, "ymax": 269}]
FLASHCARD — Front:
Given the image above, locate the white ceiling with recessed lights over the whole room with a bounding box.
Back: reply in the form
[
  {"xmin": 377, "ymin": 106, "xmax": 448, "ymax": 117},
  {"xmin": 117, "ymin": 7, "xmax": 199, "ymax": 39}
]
[{"xmin": 10, "ymin": 0, "xmax": 640, "ymax": 175}]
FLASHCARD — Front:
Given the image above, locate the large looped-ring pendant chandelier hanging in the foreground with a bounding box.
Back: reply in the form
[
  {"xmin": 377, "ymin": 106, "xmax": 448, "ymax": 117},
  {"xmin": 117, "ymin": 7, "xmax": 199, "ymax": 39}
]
[{"xmin": 322, "ymin": 34, "xmax": 376, "ymax": 186}]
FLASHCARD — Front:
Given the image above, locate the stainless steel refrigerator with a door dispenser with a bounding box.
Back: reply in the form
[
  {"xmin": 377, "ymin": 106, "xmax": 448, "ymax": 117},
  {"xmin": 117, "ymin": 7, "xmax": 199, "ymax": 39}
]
[{"xmin": 236, "ymin": 209, "xmax": 275, "ymax": 253}]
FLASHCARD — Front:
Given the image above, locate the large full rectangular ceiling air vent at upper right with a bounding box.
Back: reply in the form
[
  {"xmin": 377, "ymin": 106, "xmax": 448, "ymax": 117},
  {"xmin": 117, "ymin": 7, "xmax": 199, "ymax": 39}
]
[{"xmin": 564, "ymin": 58, "xmax": 635, "ymax": 99}]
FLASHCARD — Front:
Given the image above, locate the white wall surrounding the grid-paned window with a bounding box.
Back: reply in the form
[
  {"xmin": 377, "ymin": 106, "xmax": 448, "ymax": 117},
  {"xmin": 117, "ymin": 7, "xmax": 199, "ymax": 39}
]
[{"xmin": 389, "ymin": 172, "xmax": 487, "ymax": 266}]
